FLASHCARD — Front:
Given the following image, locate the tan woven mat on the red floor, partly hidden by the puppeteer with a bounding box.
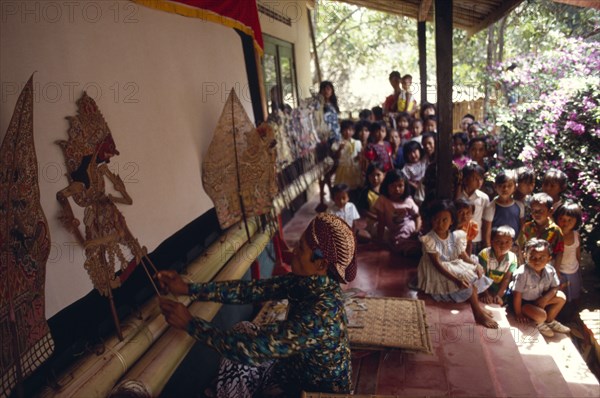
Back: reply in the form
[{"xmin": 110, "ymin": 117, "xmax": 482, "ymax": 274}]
[{"xmin": 254, "ymin": 297, "xmax": 431, "ymax": 353}]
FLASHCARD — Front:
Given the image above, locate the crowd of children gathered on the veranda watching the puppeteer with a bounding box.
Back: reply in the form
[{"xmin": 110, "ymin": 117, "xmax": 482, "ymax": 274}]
[{"xmin": 328, "ymin": 113, "xmax": 582, "ymax": 336}]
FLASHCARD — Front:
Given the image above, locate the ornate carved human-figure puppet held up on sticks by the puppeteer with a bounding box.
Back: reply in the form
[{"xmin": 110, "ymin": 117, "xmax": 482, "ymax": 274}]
[{"xmin": 56, "ymin": 92, "xmax": 145, "ymax": 298}]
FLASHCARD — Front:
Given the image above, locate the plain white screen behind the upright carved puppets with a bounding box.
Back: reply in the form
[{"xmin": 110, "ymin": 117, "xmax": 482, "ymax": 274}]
[{"xmin": 0, "ymin": 0, "xmax": 252, "ymax": 317}]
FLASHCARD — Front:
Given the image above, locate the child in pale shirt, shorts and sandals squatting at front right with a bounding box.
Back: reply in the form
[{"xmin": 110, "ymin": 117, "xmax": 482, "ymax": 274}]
[{"xmin": 512, "ymin": 238, "xmax": 571, "ymax": 337}]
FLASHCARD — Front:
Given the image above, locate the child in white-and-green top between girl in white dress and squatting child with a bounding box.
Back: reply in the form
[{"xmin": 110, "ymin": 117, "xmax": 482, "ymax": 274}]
[{"xmin": 479, "ymin": 225, "xmax": 518, "ymax": 305}]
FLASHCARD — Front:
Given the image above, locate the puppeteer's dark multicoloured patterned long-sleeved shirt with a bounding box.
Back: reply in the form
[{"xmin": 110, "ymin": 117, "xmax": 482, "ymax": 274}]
[{"xmin": 188, "ymin": 274, "xmax": 351, "ymax": 393}]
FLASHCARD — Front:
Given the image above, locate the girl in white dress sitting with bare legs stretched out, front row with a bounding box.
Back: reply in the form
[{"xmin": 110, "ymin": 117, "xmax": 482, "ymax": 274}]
[{"xmin": 418, "ymin": 201, "xmax": 498, "ymax": 329}]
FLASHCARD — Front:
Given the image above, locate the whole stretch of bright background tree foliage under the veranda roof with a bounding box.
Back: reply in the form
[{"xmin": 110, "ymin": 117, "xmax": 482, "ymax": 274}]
[{"xmin": 315, "ymin": 0, "xmax": 600, "ymax": 115}]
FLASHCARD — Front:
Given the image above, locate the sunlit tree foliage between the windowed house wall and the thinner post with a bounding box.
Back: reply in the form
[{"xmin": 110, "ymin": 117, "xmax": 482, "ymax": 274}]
[{"xmin": 315, "ymin": 1, "xmax": 435, "ymax": 115}]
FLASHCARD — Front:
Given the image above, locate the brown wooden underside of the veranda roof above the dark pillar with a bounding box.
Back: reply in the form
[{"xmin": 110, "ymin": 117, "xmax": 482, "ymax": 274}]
[{"xmin": 337, "ymin": 0, "xmax": 524, "ymax": 35}]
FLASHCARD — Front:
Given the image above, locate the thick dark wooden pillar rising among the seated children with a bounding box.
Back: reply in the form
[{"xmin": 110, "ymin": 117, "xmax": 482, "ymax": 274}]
[{"xmin": 435, "ymin": 0, "xmax": 453, "ymax": 199}]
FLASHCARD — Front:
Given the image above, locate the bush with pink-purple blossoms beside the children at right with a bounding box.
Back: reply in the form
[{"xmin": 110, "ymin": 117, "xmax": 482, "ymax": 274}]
[{"xmin": 491, "ymin": 39, "xmax": 600, "ymax": 253}]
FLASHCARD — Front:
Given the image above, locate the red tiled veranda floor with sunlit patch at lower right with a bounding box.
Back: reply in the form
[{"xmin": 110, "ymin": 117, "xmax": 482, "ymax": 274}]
[{"xmin": 284, "ymin": 188, "xmax": 600, "ymax": 397}]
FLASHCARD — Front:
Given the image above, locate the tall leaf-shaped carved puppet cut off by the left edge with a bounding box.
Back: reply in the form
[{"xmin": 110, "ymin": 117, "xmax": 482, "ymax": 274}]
[{"xmin": 0, "ymin": 75, "xmax": 54, "ymax": 397}]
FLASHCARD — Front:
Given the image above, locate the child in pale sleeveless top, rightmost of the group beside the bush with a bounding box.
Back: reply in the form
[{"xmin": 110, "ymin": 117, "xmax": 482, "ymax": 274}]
[{"xmin": 554, "ymin": 202, "xmax": 582, "ymax": 302}]
